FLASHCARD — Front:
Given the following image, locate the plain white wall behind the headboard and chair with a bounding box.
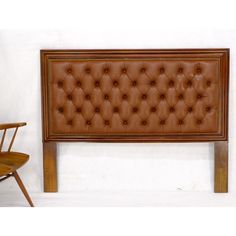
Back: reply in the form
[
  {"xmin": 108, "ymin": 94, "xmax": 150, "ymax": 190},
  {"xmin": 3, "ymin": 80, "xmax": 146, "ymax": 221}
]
[{"xmin": 0, "ymin": 29, "xmax": 236, "ymax": 205}]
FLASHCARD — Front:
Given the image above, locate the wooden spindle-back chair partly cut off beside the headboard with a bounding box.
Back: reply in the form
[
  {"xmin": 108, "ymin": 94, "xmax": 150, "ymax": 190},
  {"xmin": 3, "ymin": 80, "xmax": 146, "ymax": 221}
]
[{"xmin": 0, "ymin": 123, "xmax": 34, "ymax": 207}]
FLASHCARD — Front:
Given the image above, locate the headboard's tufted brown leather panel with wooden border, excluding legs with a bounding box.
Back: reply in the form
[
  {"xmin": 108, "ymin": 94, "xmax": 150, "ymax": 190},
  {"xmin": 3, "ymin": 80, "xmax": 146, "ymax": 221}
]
[{"xmin": 42, "ymin": 50, "xmax": 227, "ymax": 140}]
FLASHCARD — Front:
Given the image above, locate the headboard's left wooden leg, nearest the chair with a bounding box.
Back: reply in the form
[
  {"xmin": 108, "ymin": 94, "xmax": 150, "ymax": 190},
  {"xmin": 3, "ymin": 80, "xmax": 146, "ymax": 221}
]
[{"xmin": 43, "ymin": 142, "xmax": 58, "ymax": 192}]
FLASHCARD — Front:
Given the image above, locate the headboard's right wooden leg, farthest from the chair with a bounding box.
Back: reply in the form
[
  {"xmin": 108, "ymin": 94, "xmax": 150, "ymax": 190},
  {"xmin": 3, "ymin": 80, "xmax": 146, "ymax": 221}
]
[{"xmin": 215, "ymin": 141, "xmax": 228, "ymax": 193}]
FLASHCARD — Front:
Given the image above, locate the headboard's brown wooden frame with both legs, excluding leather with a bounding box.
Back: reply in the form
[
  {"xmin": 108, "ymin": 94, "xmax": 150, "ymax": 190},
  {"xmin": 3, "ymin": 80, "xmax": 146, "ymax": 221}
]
[{"xmin": 41, "ymin": 49, "xmax": 229, "ymax": 192}]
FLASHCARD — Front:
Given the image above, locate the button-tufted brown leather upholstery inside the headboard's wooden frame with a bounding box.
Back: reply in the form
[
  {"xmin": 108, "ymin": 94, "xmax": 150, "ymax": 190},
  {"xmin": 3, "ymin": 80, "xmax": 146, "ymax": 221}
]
[{"xmin": 49, "ymin": 59, "xmax": 220, "ymax": 135}]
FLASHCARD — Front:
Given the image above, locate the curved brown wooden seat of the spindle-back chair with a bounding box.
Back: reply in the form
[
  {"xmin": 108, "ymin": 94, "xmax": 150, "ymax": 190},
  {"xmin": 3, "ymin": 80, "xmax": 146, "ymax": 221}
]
[{"xmin": 0, "ymin": 152, "xmax": 29, "ymax": 176}]
